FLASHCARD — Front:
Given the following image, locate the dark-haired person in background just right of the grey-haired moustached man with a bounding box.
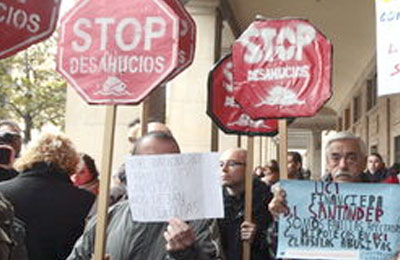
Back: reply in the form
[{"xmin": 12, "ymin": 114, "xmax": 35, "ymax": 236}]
[{"xmin": 363, "ymin": 153, "xmax": 389, "ymax": 182}]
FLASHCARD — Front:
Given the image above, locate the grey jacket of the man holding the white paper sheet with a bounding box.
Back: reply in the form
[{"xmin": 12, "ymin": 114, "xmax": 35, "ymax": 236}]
[{"xmin": 68, "ymin": 200, "xmax": 220, "ymax": 260}]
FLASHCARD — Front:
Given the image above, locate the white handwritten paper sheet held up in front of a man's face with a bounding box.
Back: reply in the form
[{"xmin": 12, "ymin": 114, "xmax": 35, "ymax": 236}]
[{"xmin": 125, "ymin": 153, "xmax": 223, "ymax": 222}]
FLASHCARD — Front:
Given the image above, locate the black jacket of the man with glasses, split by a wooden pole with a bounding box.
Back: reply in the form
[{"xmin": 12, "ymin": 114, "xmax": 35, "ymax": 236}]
[{"xmin": 218, "ymin": 178, "xmax": 272, "ymax": 260}]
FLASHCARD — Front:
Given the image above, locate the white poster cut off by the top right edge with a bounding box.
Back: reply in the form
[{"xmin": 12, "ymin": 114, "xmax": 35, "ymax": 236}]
[{"xmin": 375, "ymin": 0, "xmax": 400, "ymax": 96}]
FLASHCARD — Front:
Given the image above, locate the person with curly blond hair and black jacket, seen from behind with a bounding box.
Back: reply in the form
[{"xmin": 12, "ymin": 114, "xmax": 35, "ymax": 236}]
[{"xmin": 0, "ymin": 133, "xmax": 94, "ymax": 260}]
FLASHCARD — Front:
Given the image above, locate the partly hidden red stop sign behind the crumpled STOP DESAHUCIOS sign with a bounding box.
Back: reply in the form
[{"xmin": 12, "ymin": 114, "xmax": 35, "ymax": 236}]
[{"xmin": 207, "ymin": 55, "xmax": 278, "ymax": 136}]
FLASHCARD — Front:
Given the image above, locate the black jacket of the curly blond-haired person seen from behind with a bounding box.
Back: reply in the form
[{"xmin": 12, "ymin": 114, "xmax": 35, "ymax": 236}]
[{"xmin": 0, "ymin": 163, "xmax": 95, "ymax": 260}]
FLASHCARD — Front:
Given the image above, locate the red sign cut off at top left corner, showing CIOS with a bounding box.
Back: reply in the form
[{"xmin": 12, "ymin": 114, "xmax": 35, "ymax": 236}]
[{"xmin": 0, "ymin": 0, "xmax": 61, "ymax": 59}]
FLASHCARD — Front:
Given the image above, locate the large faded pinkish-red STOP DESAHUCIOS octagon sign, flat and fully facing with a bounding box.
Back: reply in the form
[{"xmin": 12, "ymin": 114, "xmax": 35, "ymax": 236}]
[{"xmin": 57, "ymin": 0, "xmax": 179, "ymax": 104}]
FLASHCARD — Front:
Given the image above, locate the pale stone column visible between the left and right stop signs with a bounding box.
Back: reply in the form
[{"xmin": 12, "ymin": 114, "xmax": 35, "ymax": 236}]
[{"xmin": 166, "ymin": 0, "xmax": 220, "ymax": 152}]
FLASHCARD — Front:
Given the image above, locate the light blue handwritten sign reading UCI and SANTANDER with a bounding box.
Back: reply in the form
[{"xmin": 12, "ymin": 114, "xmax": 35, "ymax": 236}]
[{"xmin": 277, "ymin": 181, "xmax": 400, "ymax": 260}]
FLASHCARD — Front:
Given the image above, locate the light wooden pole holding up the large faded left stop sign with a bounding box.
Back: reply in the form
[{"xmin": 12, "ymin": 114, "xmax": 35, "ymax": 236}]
[{"xmin": 94, "ymin": 105, "xmax": 117, "ymax": 260}]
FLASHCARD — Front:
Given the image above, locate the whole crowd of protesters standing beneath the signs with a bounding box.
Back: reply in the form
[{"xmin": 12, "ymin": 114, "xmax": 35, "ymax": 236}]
[{"xmin": 0, "ymin": 120, "xmax": 400, "ymax": 260}]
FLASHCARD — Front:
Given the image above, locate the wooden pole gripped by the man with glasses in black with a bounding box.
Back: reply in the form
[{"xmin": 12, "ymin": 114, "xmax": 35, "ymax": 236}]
[{"xmin": 242, "ymin": 136, "xmax": 254, "ymax": 260}]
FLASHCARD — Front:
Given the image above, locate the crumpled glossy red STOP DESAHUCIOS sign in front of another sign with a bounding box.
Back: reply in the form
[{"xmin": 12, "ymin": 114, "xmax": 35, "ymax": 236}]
[{"xmin": 233, "ymin": 19, "xmax": 332, "ymax": 118}]
